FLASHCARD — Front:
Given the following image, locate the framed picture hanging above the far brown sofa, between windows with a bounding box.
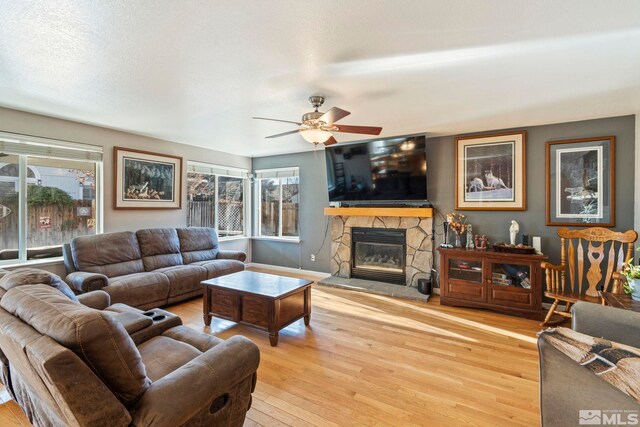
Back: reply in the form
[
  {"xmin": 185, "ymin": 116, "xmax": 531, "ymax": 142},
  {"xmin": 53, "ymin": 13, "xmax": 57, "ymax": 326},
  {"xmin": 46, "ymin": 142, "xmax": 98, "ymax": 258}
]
[{"xmin": 113, "ymin": 147, "xmax": 182, "ymax": 209}]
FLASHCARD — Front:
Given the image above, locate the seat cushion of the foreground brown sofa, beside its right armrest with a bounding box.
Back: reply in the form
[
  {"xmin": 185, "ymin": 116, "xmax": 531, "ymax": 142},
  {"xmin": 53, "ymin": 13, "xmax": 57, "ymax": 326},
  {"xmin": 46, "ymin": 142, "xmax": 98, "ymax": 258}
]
[{"xmin": 138, "ymin": 336, "xmax": 202, "ymax": 381}]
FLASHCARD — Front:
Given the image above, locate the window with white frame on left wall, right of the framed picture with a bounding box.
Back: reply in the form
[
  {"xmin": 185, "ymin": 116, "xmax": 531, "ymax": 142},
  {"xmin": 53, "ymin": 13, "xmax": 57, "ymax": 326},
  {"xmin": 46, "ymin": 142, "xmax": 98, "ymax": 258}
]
[{"xmin": 187, "ymin": 162, "xmax": 249, "ymax": 237}]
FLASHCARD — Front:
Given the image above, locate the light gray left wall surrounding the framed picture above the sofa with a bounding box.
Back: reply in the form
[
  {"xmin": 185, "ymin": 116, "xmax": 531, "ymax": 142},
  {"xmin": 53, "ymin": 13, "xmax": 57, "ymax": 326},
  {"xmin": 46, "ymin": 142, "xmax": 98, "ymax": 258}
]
[{"xmin": 0, "ymin": 108, "xmax": 251, "ymax": 272}]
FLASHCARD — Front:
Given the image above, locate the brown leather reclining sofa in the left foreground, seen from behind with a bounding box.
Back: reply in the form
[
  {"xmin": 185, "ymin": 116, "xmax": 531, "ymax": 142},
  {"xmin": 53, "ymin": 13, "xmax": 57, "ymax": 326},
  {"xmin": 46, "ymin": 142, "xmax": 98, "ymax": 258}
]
[{"xmin": 0, "ymin": 285, "xmax": 259, "ymax": 427}]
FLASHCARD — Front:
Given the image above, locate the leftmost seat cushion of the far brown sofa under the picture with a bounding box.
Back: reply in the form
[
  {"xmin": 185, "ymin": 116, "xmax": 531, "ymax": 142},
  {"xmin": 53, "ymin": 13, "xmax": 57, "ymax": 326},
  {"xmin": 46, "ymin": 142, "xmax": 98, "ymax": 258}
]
[{"xmin": 103, "ymin": 272, "xmax": 169, "ymax": 307}]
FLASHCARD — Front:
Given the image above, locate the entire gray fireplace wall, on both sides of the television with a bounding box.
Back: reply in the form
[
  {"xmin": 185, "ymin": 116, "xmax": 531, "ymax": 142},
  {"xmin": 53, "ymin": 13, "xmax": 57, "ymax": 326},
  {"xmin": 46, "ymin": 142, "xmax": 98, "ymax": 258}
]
[{"xmin": 253, "ymin": 116, "xmax": 635, "ymax": 280}]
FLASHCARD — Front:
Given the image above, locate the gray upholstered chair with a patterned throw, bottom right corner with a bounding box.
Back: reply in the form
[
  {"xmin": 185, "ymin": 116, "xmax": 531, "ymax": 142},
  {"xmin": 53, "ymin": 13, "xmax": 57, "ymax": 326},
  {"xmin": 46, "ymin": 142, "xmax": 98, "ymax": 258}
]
[{"xmin": 538, "ymin": 302, "xmax": 640, "ymax": 427}]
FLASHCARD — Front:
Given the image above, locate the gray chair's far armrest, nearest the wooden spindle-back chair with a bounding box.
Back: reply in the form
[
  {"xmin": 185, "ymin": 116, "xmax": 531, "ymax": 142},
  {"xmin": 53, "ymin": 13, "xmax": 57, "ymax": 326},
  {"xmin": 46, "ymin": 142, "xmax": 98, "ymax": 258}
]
[{"xmin": 571, "ymin": 302, "xmax": 640, "ymax": 348}]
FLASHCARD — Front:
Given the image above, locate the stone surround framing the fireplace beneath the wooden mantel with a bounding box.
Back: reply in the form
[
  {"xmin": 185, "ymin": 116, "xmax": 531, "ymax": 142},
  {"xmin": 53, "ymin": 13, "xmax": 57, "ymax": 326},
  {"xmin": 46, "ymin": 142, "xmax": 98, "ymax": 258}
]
[{"xmin": 331, "ymin": 216, "xmax": 433, "ymax": 286}]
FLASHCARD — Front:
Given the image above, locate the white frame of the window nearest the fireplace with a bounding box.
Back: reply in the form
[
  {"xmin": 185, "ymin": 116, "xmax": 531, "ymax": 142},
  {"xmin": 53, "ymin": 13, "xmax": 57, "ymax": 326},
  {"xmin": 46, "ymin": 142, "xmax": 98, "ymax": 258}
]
[{"xmin": 253, "ymin": 166, "xmax": 301, "ymax": 243}]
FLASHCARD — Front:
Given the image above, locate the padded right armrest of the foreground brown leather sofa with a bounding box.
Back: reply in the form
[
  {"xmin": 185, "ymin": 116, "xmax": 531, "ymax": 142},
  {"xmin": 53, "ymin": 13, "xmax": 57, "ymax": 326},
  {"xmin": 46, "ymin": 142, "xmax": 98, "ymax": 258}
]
[{"xmin": 130, "ymin": 336, "xmax": 260, "ymax": 427}]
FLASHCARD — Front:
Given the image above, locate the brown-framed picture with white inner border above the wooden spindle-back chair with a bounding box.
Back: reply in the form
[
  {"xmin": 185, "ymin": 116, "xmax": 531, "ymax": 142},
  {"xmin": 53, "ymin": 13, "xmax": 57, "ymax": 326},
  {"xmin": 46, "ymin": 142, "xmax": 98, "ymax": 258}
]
[{"xmin": 546, "ymin": 136, "xmax": 615, "ymax": 227}]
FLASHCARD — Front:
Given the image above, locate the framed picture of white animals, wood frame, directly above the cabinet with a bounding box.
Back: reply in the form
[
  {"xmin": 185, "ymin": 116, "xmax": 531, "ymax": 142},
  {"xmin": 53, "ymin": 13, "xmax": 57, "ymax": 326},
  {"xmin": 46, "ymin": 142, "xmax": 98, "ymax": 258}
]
[{"xmin": 455, "ymin": 131, "xmax": 527, "ymax": 211}]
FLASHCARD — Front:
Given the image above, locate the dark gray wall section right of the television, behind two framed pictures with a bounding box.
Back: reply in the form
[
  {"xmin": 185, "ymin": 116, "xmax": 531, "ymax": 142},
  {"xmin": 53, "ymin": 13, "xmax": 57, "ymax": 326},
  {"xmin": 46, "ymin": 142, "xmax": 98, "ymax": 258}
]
[{"xmin": 427, "ymin": 116, "xmax": 635, "ymax": 282}]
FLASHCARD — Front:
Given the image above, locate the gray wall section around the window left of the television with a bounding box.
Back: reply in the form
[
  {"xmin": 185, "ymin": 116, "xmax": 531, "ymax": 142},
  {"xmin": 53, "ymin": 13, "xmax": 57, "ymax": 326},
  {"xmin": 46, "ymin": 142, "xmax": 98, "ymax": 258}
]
[{"xmin": 251, "ymin": 150, "xmax": 331, "ymax": 272}]
